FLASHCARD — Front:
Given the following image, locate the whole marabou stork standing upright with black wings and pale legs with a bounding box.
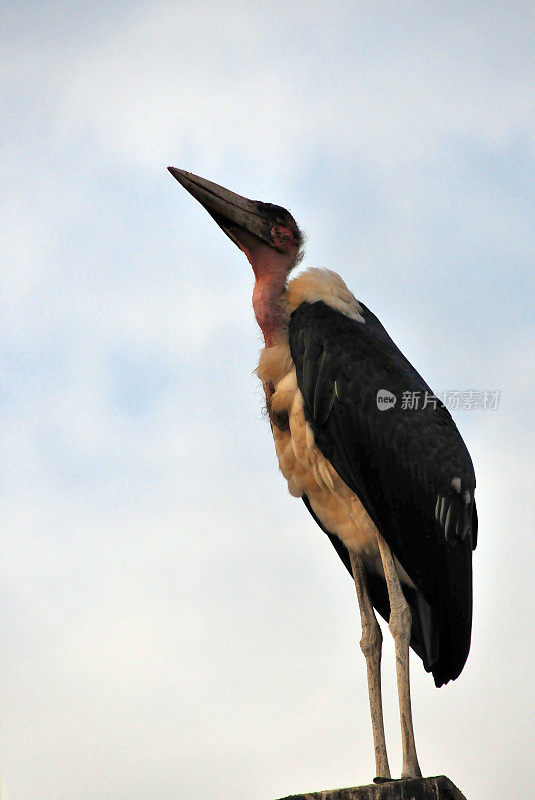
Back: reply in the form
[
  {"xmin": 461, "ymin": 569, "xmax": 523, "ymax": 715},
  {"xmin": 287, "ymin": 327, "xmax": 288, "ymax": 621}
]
[{"xmin": 169, "ymin": 167, "xmax": 477, "ymax": 781}]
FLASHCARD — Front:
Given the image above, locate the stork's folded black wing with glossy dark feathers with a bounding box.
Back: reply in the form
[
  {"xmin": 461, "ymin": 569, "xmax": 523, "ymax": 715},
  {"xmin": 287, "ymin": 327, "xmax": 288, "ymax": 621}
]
[{"xmin": 289, "ymin": 302, "xmax": 477, "ymax": 686}]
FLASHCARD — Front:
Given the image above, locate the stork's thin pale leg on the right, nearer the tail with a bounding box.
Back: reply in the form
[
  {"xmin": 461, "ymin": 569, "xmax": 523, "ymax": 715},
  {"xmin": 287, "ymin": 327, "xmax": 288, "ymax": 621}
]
[{"xmin": 377, "ymin": 532, "xmax": 422, "ymax": 778}]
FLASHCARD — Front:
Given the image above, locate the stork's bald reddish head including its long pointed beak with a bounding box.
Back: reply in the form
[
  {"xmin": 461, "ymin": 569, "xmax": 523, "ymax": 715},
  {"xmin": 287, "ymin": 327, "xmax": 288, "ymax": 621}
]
[{"xmin": 168, "ymin": 167, "xmax": 303, "ymax": 280}]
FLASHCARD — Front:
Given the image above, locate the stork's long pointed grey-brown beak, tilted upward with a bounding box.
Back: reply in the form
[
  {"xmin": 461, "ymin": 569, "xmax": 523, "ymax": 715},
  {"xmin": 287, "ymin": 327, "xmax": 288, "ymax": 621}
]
[{"xmin": 167, "ymin": 167, "xmax": 279, "ymax": 249}]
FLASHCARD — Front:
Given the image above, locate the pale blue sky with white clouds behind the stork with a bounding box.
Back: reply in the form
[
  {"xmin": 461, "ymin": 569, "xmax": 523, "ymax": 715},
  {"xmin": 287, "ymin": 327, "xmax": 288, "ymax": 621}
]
[{"xmin": 0, "ymin": 0, "xmax": 535, "ymax": 800}]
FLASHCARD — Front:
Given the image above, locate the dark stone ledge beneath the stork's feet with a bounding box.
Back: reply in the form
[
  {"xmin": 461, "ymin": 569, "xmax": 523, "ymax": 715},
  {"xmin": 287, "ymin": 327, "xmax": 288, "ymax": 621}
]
[{"xmin": 281, "ymin": 775, "xmax": 466, "ymax": 800}]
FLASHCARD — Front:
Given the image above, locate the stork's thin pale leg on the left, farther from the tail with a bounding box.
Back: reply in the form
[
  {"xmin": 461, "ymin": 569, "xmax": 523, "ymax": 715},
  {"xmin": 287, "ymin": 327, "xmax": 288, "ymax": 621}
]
[{"xmin": 349, "ymin": 551, "xmax": 390, "ymax": 778}]
